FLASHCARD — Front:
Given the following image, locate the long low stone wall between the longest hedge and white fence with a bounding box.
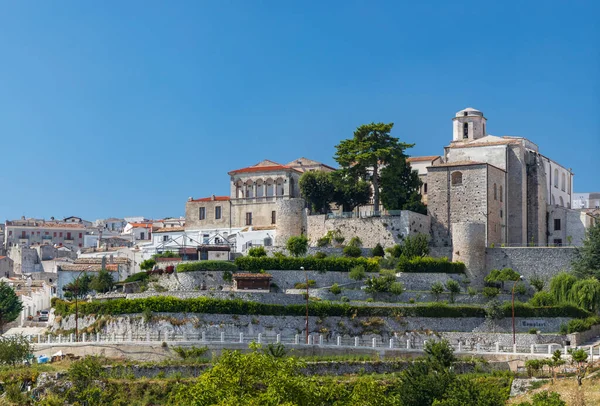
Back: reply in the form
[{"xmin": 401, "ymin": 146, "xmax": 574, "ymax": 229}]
[{"xmin": 55, "ymin": 313, "xmax": 571, "ymax": 336}]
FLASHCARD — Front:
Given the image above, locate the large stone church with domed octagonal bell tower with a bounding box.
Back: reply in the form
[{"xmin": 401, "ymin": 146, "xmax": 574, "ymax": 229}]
[{"xmin": 413, "ymin": 107, "xmax": 575, "ymax": 246}]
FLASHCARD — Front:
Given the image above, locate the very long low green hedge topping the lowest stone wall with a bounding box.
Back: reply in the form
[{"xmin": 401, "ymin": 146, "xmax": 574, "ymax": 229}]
[{"xmin": 52, "ymin": 296, "xmax": 587, "ymax": 318}]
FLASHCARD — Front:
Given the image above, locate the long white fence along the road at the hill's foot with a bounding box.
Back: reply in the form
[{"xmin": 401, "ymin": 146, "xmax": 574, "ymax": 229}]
[{"xmin": 21, "ymin": 331, "xmax": 600, "ymax": 361}]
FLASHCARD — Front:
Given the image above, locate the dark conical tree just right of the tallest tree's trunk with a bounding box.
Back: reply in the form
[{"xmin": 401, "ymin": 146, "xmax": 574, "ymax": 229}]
[{"xmin": 380, "ymin": 148, "xmax": 427, "ymax": 214}]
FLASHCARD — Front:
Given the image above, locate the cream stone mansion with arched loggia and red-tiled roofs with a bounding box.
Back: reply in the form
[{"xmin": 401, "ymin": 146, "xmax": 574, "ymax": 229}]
[{"xmin": 185, "ymin": 158, "xmax": 335, "ymax": 252}]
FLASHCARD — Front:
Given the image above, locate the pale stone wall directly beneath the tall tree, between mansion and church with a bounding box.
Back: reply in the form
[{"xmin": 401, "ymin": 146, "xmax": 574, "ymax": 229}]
[{"xmin": 307, "ymin": 210, "xmax": 430, "ymax": 248}]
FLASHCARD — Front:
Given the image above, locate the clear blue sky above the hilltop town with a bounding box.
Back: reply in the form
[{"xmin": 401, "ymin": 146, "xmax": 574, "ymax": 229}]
[{"xmin": 0, "ymin": 0, "xmax": 600, "ymax": 220}]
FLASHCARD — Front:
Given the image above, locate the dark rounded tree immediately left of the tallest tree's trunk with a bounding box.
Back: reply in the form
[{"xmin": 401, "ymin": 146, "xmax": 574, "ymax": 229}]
[{"xmin": 330, "ymin": 169, "xmax": 371, "ymax": 212}]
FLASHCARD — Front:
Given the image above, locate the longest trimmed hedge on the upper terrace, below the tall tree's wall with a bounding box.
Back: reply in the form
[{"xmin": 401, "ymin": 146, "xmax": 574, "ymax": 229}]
[{"xmin": 235, "ymin": 257, "xmax": 379, "ymax": 272}]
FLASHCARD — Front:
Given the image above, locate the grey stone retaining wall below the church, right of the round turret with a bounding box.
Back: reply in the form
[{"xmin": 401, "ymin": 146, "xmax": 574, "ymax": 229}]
[{"xmin": 486, "ymin": 247, "xmax": 577, "ymax": 281}]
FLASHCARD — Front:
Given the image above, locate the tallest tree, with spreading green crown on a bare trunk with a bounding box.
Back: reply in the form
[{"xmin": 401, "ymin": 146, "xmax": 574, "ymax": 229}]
[{"xmin": 334, "ymin": 123, "xmax": 412, "ymax": 212}]
